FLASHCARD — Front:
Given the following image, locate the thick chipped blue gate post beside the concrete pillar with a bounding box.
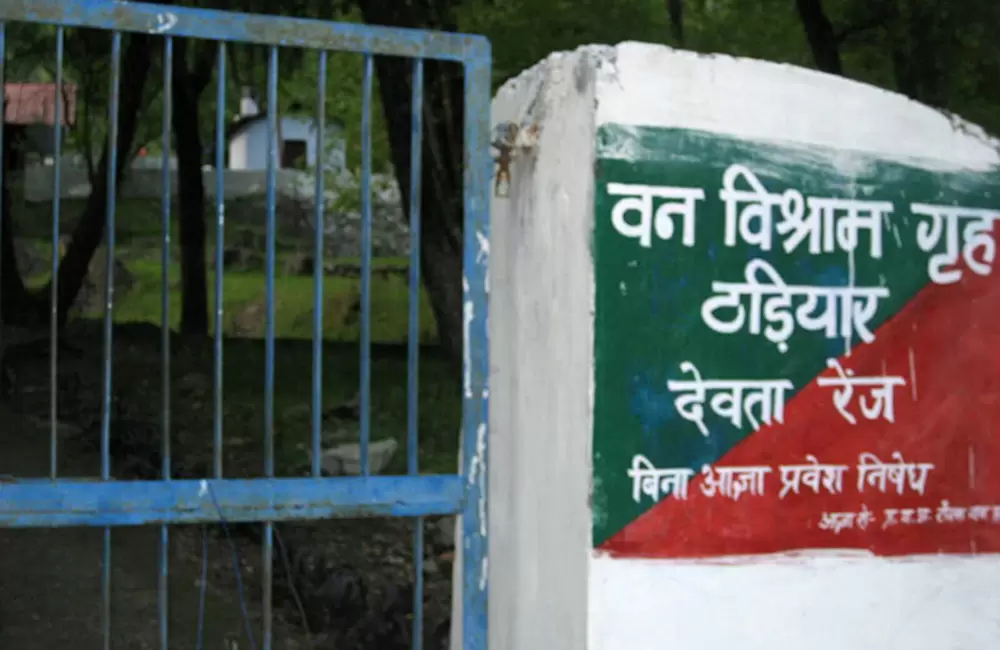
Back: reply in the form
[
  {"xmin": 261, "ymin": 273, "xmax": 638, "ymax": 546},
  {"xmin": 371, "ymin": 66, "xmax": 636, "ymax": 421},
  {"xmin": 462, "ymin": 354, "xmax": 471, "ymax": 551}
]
[{"xmin": 462, "ymin": 38, "xmax": 493, "ymax": 650}]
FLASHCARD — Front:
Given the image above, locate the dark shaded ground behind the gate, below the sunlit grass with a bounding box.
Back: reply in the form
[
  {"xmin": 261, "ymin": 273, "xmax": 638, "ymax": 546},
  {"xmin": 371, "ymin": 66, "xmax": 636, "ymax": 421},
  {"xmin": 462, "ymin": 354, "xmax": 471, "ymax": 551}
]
[{"xmin": 0, "ymin": 326, "xmax": 454, "ymax": 650}]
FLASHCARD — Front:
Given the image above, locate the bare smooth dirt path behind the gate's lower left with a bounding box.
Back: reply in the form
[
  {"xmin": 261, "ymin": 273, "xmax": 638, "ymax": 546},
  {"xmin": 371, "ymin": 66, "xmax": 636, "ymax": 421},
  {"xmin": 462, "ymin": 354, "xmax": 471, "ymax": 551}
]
[{"xmin": 0, "ymin": 410, "xmax": 312, "ymax": 650}]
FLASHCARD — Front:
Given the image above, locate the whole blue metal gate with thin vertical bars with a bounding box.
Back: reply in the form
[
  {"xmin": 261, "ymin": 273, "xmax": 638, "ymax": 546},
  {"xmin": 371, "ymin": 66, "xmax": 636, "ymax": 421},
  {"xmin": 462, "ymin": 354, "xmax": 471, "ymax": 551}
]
[{"xmin": 0, "ymin": 0, "xmax": 492, "ymax": 650}]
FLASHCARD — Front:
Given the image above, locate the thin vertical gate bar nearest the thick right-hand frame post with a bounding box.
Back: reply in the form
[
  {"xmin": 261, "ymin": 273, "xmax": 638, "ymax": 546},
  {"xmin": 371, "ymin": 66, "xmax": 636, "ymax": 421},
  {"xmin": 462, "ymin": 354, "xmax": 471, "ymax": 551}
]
[{"xmin": 406, "ymin": 59, "xmax": 424, "ymax": 650}]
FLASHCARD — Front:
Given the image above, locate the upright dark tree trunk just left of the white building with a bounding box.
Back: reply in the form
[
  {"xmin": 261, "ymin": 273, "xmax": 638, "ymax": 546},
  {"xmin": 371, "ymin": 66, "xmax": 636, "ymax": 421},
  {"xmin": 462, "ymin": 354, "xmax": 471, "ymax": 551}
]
[{"xmin": 172, "ymin": 39, "xmax": 212, "ymax": 334}]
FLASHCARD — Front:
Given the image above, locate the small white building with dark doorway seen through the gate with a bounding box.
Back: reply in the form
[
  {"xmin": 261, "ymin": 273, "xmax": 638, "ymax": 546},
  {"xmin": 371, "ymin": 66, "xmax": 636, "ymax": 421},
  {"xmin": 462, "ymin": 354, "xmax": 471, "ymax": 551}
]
[{"xmin": 228, "ymin": 90, "xmax": 346, "ymax": 171}]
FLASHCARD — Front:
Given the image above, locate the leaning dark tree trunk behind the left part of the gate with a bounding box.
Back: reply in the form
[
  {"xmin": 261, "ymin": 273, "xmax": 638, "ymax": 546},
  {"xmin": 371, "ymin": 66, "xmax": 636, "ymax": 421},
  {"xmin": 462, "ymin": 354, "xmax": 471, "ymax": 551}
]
[{"xmin": 47, "ymin": 34, "xmax": 151, "ymax": 323}]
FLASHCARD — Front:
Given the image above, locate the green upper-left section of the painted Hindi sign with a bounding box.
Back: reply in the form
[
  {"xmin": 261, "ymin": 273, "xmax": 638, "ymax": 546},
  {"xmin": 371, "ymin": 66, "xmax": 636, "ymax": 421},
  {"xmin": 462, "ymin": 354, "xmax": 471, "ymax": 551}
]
[{"xmin": 593, "ymin": 125, "xmax": 1000, "ymax": 547}]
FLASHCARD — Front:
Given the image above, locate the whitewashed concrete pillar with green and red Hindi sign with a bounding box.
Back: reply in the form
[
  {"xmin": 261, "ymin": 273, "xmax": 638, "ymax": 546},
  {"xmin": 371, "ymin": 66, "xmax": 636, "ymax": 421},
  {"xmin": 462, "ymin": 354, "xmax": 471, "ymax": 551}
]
[{"xmin": 480, "ymin": 43, "xmax": 1000, "ymax": 650}]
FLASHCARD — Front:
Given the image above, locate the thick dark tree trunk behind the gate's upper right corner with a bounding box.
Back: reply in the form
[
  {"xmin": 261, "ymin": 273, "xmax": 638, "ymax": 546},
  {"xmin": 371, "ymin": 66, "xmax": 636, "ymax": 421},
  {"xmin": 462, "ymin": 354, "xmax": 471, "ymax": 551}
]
[{"xmin": 358, "ymin": 0, "xmax": 465, "ymax": 365}]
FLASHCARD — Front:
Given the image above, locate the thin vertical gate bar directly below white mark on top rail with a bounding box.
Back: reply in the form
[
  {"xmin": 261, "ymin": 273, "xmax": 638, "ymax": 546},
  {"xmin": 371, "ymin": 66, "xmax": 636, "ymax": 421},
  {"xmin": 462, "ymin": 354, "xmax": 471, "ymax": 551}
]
[{"xmin": 159, "ymin": 36, "xmax": 174, "ymax": 650}]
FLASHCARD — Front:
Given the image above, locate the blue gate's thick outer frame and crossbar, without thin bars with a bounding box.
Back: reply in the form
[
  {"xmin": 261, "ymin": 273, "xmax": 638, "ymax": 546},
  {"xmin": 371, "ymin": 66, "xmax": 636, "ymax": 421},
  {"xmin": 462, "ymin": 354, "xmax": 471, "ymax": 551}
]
[{"xmin": 0, "ymin": 0, "xmax": 493, "ymax": 650}]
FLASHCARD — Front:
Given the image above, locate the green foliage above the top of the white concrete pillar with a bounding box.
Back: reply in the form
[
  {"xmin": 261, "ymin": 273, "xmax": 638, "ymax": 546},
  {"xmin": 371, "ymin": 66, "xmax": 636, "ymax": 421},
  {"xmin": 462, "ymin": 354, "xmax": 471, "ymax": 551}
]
[{"xmin": 458, "ymin": 0, "xmax": 1000, "ymax": 133}]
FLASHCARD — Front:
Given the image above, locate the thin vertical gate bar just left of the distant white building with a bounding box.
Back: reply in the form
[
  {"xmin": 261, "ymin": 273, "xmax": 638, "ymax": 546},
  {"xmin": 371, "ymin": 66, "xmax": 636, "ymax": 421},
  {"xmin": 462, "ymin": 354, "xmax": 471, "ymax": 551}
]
[{"xmin": 212, "ymin": 41, "xmax": 226, "ymax": 478}]
